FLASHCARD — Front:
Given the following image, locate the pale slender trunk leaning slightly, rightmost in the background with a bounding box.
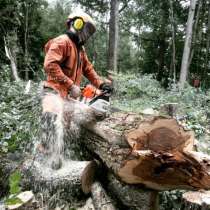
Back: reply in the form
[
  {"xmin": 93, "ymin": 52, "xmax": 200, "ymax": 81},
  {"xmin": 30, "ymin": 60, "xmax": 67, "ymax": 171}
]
[{"xmin": 179, "ymin": 0, "xmax": 197, "ymax": 89}]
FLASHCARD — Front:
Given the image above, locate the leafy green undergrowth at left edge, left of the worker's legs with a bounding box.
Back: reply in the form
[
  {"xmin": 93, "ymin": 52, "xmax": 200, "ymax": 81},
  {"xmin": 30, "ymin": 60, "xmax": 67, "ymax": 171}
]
[{"xmin": 0, "ymin": 82, "xmax": 40, "ymax": 153}]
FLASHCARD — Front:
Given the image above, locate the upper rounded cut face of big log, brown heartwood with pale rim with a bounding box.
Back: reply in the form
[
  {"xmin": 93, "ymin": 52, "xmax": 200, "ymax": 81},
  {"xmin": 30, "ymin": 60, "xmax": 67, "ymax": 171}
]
[{"xmin": 126, "ymin": 117, "xmax": 194, "ymax": 153}]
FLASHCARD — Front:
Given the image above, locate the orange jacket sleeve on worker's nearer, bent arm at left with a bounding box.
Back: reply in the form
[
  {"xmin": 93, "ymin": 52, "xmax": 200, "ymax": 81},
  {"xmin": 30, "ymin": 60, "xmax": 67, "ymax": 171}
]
[{"xmin": 44, "ymin": 40, "xmax": 73, "ymax": 90}]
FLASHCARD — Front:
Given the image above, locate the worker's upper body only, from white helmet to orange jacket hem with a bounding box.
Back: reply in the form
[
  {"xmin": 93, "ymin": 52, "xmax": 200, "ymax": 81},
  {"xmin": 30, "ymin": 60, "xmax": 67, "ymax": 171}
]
[{"xmin": 44, "ymin": 12, "xmax": 112, "ymax": 98}]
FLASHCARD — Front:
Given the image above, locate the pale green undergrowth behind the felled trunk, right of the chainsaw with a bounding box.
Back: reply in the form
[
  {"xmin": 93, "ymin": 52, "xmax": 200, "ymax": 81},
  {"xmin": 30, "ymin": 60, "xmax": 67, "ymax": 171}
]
[{"xmin": 112, "ymin": 74, "xmax": 210, "ymax": 140}]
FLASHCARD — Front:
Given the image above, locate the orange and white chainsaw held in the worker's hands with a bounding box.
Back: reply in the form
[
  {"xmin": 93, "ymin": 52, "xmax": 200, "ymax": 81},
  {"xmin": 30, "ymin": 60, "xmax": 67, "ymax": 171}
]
[{"xmin": 80, "ymin": 85, "xmax": 111, "ymax": 114}]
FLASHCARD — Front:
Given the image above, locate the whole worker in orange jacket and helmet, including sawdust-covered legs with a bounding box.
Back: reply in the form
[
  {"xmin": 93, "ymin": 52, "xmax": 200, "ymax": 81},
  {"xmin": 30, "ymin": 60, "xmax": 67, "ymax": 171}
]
[{"xmin": 37, "ymin": 13, "xmax": 112, "ymax": 169}]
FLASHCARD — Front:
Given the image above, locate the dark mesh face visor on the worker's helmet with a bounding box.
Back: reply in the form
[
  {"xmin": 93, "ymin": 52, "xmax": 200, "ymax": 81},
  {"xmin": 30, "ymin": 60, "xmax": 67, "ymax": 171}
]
[{"xmin": 78, "ymin": 22, "xmax": 96, "ymax": 43}]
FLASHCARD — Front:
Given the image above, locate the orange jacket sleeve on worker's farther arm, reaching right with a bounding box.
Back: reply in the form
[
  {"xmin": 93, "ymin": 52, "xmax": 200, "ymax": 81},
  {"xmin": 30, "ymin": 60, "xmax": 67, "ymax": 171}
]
[{"xmin": 83, "ymin": 52, "xmax": 103, "ymax": 88}]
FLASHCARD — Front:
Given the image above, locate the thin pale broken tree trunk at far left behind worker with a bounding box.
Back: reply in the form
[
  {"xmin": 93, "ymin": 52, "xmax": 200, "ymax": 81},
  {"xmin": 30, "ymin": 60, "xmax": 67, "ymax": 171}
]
[{"xmin": 4, "ymin": 32, "xmax": 20, "ymax": 81}]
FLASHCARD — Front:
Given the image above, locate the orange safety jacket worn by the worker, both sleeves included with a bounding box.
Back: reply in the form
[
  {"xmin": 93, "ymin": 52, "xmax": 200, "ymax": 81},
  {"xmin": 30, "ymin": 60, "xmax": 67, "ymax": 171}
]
[{"xmin": 44, "ymin": 34, "xmax": 103, "ymax": 98}]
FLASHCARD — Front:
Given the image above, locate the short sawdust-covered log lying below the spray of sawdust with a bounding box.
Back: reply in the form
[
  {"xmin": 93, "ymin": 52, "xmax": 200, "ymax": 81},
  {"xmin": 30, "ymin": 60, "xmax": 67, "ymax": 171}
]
[{"xmin": 22, "ymin": 160, "xmax": 97, "ymax": 196}]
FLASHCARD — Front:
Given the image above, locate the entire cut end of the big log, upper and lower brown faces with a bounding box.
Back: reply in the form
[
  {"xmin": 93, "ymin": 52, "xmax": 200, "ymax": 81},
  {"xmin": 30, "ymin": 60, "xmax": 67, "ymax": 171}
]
[{"xmin": 118, "ymin": 117, "xmax": 203, "ymax": 190}]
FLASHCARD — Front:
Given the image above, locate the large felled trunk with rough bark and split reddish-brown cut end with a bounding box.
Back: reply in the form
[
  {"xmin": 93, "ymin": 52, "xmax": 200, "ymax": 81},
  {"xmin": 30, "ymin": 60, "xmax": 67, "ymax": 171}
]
[{"xmin": 76, "ymin": 110, "xmax": 210, "ymax": 190}]
